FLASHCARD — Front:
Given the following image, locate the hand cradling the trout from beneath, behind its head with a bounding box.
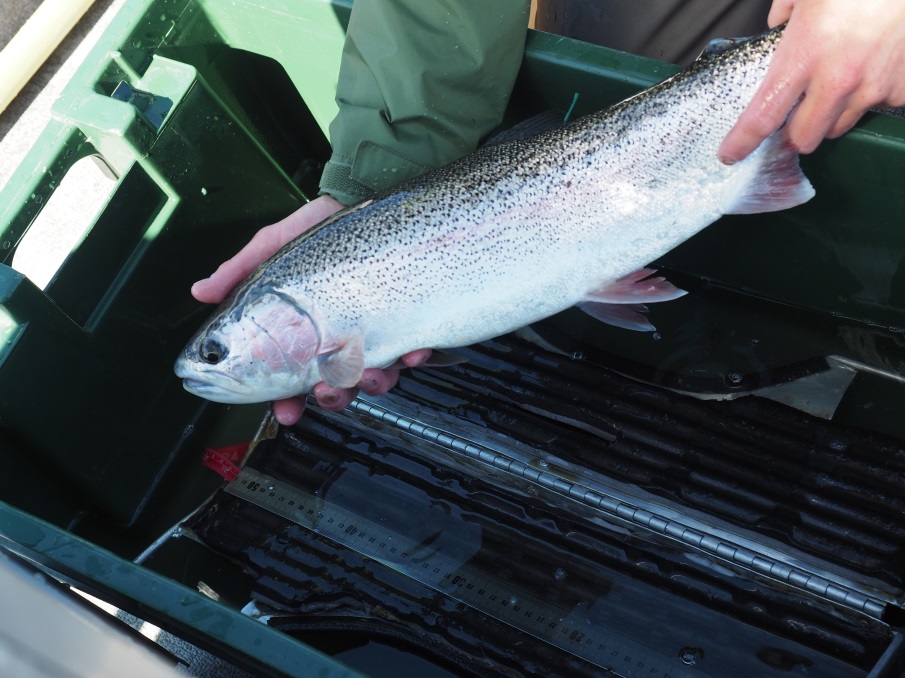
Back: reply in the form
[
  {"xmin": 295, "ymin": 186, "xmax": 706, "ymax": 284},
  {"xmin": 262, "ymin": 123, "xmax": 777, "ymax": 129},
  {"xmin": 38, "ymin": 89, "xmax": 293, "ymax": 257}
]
[{"xmin": 192, "ymin": 195, "xmax": 431, "ymax": 426}]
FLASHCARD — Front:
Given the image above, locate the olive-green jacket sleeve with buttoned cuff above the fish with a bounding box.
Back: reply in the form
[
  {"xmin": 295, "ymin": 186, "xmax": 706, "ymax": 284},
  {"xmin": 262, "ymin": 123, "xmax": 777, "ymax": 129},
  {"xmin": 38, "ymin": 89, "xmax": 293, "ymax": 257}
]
[{"xmin": 321, "ymin": 0, "xmax": 530, "ymax": 205}]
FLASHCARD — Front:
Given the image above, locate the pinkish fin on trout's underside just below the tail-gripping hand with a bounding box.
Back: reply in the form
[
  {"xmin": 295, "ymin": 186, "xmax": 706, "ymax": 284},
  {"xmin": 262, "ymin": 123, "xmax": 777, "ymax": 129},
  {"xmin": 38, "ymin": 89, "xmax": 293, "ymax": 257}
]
[{"xmin": 722, "ymin": 130, "xmax": 814, "ymax": 214}]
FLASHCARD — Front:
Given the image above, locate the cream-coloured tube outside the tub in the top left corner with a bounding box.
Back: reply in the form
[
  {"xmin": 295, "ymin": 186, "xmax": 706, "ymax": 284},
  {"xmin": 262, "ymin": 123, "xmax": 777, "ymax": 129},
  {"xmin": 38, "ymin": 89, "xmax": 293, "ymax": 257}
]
[{"xmin": 0, "ymin": 0, "xmax": 94, "ymax": 113}]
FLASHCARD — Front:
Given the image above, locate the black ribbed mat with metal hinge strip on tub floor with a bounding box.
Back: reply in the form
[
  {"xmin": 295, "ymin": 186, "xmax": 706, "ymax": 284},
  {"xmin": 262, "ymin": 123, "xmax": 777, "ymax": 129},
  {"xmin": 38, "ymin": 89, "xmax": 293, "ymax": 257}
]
[{"xmin": 189, "ymin": 326, "xmax": 905, "ymax": 677}]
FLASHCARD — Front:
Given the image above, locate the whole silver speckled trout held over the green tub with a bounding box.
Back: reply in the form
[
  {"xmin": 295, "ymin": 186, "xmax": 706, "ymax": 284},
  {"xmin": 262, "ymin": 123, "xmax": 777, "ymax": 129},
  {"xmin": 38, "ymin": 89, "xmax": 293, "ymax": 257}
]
[{"xmin": 176, "ymin": 29, "xmax": 814, "ymax": 403}]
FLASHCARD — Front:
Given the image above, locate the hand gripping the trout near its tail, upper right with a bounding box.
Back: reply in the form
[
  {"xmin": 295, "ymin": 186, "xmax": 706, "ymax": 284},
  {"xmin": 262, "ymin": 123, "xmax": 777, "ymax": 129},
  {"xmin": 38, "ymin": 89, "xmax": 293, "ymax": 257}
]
[{"xmin": 717, "ymin": 0, "xmax": 905, "ymax": 164}]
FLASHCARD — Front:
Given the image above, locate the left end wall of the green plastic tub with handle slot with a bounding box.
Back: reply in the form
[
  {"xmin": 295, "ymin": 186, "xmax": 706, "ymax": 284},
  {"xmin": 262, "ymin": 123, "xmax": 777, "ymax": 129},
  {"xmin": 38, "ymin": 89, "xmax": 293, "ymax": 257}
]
[{"xmin": 0, "ymin": 2, "xmax": 342, "ymax": 524}]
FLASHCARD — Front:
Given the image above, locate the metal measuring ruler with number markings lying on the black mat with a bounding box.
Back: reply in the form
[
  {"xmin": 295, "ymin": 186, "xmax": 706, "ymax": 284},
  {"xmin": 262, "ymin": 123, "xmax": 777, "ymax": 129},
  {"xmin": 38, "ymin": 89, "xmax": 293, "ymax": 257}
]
[{"xmin": 226, "ymin": 467, "xmax": 705, "ymax": 678}]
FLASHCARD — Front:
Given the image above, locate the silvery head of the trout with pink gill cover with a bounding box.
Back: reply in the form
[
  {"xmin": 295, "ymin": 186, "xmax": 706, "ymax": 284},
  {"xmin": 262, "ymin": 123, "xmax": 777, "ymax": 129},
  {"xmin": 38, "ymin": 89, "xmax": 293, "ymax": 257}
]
[{"xmin": 175, "ymin": 290, "xmax": 320, "ymax": 404}]
